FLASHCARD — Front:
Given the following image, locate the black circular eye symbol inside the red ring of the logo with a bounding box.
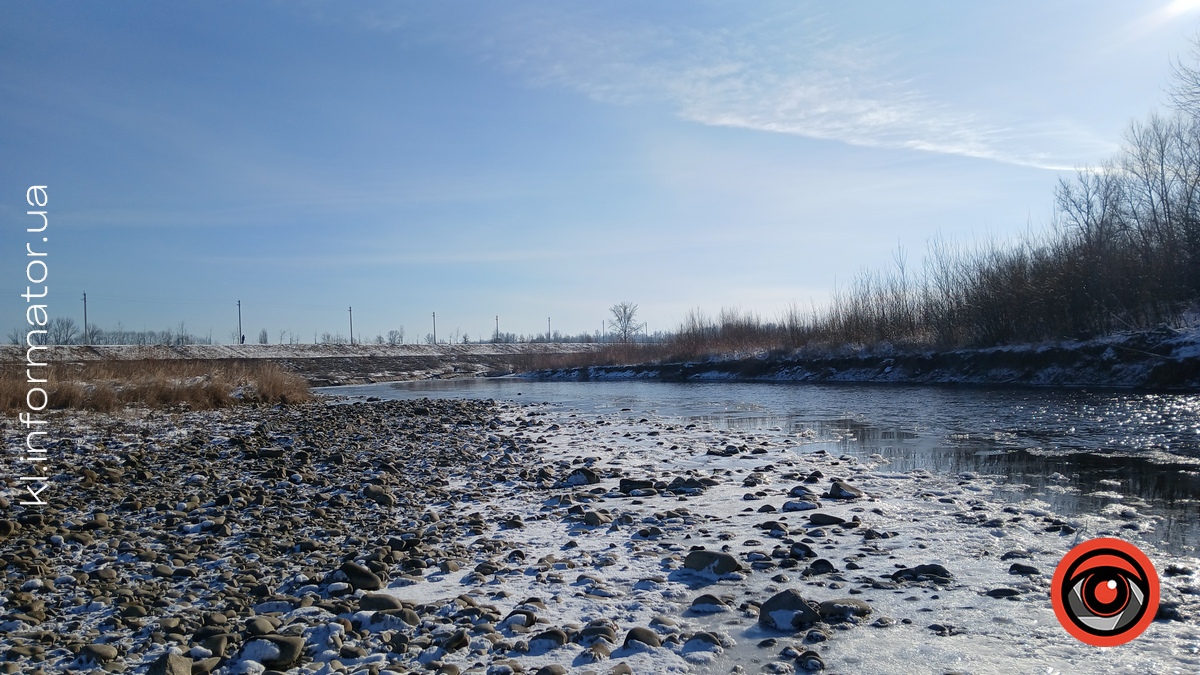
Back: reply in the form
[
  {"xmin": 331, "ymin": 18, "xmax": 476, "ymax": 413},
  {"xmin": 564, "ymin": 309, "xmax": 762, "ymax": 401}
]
[{"xmin": 1061, "ymin": 550, "xmax": 1150, "ymax": 637}]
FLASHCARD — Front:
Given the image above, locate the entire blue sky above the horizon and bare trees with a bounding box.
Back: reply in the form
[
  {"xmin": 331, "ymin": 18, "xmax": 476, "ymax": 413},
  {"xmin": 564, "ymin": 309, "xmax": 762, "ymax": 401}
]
[{"xmin": 0, "ymin": 0, "xmax": 1200, "ymax": 344}]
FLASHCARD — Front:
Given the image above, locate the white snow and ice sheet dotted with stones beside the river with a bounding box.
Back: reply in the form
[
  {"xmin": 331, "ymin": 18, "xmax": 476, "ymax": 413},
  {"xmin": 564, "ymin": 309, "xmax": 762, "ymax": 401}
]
[{"xmin": 350, "ymin": 406, "xmax": 1200, "ymax": 674}]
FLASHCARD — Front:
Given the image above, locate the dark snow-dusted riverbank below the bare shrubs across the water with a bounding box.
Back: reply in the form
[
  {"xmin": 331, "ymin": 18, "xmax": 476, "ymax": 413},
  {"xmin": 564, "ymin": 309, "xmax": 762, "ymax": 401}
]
[{"xmin": 524, "ymin": 327, "xmax": 1200, "ymax": 392}]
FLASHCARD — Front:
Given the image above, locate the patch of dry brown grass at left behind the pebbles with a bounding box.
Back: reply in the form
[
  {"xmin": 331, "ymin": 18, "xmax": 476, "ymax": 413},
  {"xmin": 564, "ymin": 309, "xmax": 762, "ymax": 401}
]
[{"xmin": 0, "ymin": 360, "xmax": 312, "ymax": 412}]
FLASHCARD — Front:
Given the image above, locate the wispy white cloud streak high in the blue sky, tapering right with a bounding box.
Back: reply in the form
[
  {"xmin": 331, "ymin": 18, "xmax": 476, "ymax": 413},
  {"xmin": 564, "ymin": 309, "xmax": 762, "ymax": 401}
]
[{"xmin": 453, "ymin": 5, "xmax": 1114, "ymax": 169}]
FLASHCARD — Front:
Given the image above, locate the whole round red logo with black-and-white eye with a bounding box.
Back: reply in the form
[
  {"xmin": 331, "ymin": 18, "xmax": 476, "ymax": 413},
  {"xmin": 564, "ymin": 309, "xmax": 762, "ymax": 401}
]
[{"xmin": 1050, "ymin": 538, "xmax": 1158, "ymax": 647}]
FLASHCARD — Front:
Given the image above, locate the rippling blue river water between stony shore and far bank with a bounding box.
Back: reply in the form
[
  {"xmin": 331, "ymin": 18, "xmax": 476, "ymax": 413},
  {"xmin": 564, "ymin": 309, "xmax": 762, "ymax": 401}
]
[{"xmin": 320, "ymin": 378, "xmax": 1200, "ymax": 555}]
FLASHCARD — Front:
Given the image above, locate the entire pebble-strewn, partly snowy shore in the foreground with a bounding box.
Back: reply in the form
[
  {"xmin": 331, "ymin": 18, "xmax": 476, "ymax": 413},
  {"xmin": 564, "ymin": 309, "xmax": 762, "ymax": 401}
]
[{"xmin": 0, "ymin": 400, "xmax": 1200, "ymax": 675}]
